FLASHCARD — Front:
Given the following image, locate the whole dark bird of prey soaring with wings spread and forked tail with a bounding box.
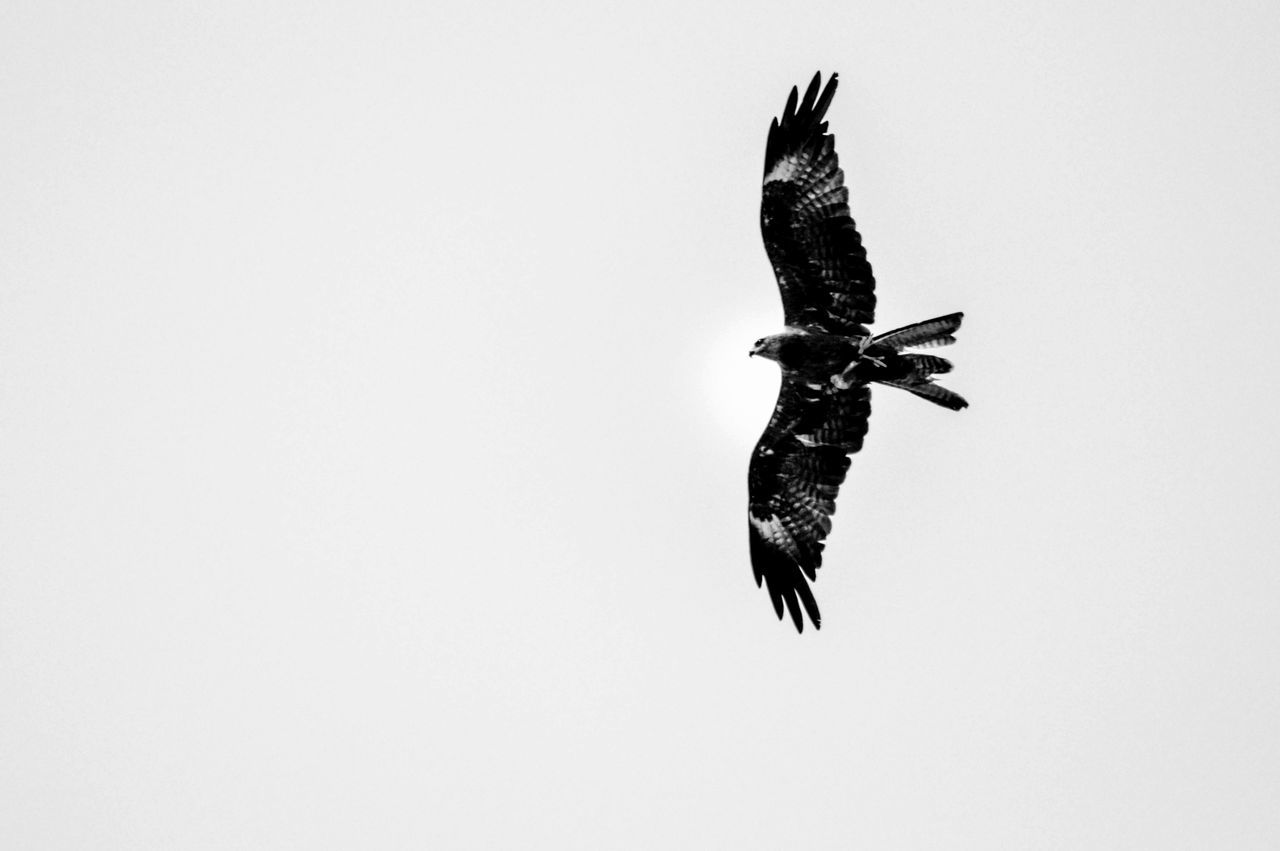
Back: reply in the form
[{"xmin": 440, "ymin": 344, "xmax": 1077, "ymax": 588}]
[{"xmin": 748, "ymin": 73, "xmax": 969, "ymax": 632}]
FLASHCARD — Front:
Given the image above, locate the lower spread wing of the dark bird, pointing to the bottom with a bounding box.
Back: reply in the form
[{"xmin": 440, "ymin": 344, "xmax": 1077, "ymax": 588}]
[{"xmin": 748, "ymin": 372, "xmax": 872, "ymax": 632}]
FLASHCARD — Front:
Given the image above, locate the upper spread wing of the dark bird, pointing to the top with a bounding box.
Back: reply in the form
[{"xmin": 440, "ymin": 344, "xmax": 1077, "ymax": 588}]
[{"xmin": 760, "ymin": 73, "xmax": 876, "ymax": 335}]
